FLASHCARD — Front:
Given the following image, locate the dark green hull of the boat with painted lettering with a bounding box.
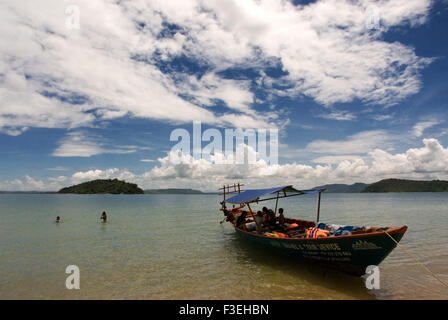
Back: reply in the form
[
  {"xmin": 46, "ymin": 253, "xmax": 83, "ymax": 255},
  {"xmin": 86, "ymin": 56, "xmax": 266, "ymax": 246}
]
[{"xmin": 235, "ymin": 226, "xmax": 407, "ymax": 276}]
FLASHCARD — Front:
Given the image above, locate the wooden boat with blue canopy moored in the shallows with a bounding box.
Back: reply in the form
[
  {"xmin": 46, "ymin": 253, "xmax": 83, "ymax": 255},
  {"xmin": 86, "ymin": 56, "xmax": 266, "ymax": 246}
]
[{"xmin": 220, "ymin": 184, "xmax": 407, "ymax": 276}]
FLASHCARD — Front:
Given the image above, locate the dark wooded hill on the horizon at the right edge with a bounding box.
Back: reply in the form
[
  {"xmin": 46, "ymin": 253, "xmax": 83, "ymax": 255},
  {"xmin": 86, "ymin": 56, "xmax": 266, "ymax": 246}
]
[{"xmin": 361, "ymin": 179, "xmax": 448, "ymax": 192}]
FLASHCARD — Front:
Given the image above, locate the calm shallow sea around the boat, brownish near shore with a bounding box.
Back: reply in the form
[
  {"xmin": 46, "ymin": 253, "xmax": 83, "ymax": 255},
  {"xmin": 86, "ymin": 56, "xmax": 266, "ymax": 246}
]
[{"xmin": 0, "ymin": 193, "xmax": 448, "ymax": 299}]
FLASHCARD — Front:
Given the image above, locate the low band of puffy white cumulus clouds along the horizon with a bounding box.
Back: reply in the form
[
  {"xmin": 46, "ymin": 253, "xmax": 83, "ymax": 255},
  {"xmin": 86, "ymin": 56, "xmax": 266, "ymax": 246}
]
[{"xmin": 4, "ymin": 138, "xmax": 448, "ymax": 190}]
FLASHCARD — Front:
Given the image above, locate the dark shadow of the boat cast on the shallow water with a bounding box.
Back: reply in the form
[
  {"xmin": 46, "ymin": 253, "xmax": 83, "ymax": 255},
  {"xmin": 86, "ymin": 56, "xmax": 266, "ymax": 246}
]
[{"xmin": 223, "ymin": 234, "xmax": 376, "ymax": 299}]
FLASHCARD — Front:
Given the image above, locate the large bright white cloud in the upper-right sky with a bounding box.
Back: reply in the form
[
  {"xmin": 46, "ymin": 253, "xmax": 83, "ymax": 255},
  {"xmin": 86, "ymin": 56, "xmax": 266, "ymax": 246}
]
[{"xmin": 190, "ymin": 0, "xmax": 430, "ymax": 105}]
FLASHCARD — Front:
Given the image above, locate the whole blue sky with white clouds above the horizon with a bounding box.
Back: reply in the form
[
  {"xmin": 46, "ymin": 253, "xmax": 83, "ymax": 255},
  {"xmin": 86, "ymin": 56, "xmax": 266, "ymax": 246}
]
[{"xmin": 0, "ymin": 0, "xmax": 448, "ymax": 191}]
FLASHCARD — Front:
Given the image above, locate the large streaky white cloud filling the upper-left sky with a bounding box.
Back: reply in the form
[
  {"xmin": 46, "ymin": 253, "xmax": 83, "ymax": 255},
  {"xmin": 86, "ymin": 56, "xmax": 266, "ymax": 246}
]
[{"xmin": 0, "ymin": 0, "xmax": 276, "ymax": 134}]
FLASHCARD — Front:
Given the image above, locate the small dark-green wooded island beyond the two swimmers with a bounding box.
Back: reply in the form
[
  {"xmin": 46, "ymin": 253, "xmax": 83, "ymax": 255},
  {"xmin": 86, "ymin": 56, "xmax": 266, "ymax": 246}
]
[{"xmin": 58, "ymin": 179, "xmax": 144, "ymax": 194}]
